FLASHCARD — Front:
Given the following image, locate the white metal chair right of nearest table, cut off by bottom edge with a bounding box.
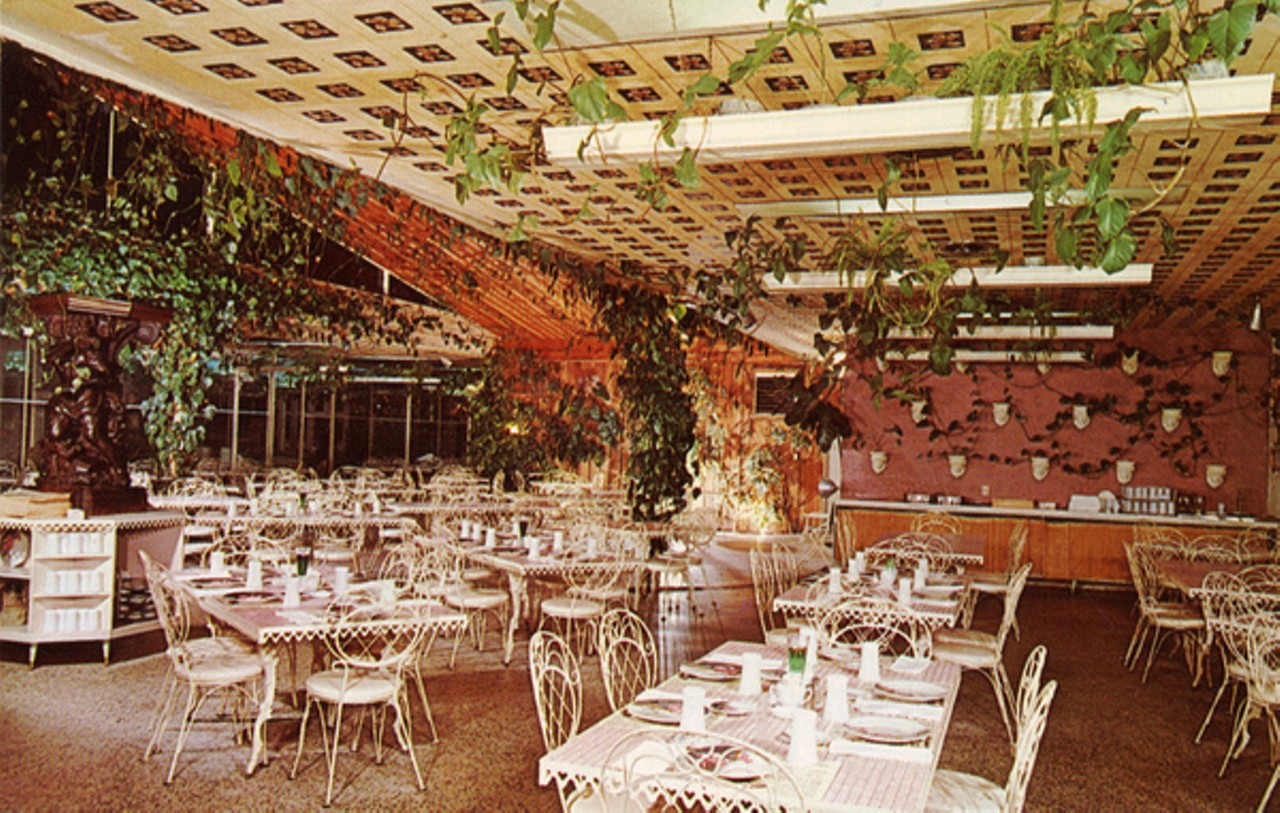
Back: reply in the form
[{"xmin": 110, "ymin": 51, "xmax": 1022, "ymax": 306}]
[{"xmin": 924, "ymin": 647, "xmax": 1057, "ymax": 813}]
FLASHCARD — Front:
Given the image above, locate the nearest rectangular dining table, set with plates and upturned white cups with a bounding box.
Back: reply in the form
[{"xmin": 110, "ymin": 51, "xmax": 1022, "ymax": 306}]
[{"xmin": 539, "ymin": 641, "xmax": 960, "ymax": 812}]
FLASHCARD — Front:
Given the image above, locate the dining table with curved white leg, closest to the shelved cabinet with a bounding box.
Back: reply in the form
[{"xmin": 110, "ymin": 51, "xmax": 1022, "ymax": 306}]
[{"xmin": 174, "ymin": 568, "xmax": 467, "ymax": 773}]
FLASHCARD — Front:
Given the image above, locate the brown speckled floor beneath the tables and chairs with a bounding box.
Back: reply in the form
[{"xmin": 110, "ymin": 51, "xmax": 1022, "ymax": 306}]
[{"xmin": 0, "ymin": 547, "xmax": 1280, "ymax": 810}]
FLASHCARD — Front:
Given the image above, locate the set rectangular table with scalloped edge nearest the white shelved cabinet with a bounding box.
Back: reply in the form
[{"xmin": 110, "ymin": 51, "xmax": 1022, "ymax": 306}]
[{"xmin": 174, "ymin": 571, "xmax": 467, "ymax": 773}]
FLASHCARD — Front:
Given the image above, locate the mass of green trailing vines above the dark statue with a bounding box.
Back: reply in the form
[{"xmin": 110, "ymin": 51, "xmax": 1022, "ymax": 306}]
[{"xmin": 0, "ymin": 44, "xmax": 448, "ymax": 471}]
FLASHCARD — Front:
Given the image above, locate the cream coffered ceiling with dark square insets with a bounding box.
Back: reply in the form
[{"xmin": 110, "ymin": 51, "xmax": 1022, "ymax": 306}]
[{"xmin": 0, "ymin": 0, "xmax": 1280, "ymax": 358}]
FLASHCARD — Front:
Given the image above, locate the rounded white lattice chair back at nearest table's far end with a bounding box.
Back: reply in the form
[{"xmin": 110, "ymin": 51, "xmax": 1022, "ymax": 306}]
[{"xmin": 818, "ymin": 595, "xmax": 933, "ymax": 658}]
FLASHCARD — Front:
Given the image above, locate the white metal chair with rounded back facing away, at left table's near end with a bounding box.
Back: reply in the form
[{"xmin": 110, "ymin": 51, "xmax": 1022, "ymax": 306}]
[{"xmin": 289, "ymin": 603, "xmax": 426, "ymax": 807}]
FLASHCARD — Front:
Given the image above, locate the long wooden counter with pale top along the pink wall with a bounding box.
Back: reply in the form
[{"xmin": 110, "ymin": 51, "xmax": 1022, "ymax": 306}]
[{"xmin": 836, "ymin": 499, "xmax": 1280, "ymax": 584}]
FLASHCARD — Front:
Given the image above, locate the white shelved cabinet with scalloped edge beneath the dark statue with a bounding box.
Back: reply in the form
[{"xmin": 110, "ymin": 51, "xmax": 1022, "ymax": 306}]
[{"xmin": 0, "ymin": 512, "xmax": 183, "ymax": 666}]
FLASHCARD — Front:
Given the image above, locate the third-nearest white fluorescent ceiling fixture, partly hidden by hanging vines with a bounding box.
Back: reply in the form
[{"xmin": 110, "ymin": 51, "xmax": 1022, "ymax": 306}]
[{"xmin": 760, "ymin": 262, "xmax": 1152, "ymax": 293}]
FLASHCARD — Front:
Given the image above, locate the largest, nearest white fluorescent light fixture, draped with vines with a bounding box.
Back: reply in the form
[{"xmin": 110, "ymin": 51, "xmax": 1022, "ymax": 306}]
[{"xmin": 543, "ymin": 73, "xmax": 1275, "ymax": 166}]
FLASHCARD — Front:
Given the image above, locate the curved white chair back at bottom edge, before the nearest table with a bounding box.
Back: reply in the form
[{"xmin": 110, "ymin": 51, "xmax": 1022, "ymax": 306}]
[{"xmin": 600, "ymin": 728, "xmax": 808, "ymax": 813}]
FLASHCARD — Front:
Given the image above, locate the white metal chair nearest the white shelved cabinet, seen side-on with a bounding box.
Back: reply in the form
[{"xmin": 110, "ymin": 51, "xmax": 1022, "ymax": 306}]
[{"xmin": 138, "ymin": 552, "xmax": 273, "ymax": 785}]
